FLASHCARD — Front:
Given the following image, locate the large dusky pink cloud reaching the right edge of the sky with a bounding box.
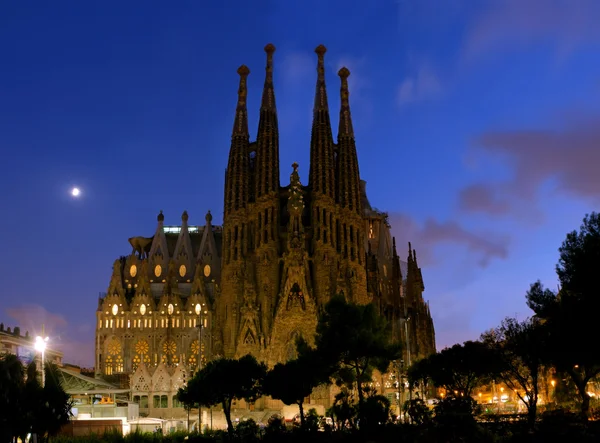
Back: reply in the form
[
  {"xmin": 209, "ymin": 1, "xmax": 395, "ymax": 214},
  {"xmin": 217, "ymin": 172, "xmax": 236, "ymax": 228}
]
[{"xmin": 459, "ymin": 117, "xmax": 600, "ymax": 215}]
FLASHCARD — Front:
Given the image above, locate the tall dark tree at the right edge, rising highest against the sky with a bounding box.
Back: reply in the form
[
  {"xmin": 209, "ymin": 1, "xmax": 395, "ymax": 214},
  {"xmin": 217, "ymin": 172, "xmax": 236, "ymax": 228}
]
[{"xmin": 527, "ymin": 213, "xmax": 600, "ymax": 419}]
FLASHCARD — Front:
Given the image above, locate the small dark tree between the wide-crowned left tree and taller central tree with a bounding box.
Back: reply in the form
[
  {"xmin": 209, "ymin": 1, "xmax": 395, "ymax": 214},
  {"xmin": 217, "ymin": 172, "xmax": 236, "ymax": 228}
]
[{"xmin": 263, "ymin": 350, "xmax": 323, "ymax": 429}]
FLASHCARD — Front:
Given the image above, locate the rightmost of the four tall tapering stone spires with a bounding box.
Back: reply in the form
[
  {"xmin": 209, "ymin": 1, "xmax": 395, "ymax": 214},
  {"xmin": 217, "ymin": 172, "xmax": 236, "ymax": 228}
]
[{"xmin": 337, "ymin": 68, "xmax": 362, "ymax": 214}]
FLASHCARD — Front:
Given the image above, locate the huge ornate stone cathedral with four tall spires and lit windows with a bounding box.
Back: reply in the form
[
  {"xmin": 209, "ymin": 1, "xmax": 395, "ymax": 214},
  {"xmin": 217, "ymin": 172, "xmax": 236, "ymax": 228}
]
[{"xmin": 95, "ymin": 44, "xmax": 435, "ymax": 416}]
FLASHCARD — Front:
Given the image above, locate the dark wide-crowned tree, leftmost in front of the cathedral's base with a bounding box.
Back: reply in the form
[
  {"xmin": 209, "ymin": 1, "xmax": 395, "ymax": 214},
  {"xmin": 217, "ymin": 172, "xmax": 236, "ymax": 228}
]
[{"xmin": 187, "ymin": 355, "xmax": 267, "ymax": 437}]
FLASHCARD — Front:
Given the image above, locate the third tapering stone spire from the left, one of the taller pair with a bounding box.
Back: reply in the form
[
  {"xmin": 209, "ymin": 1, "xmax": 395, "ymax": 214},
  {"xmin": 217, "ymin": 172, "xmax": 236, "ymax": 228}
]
[{"xmin": 309, "ymin": 45, "xmax": 335, "ymax": 199}]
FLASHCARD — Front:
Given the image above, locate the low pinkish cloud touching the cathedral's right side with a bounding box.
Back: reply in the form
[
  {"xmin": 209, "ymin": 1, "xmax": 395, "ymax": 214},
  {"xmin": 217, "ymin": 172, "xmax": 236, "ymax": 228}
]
[{"xmin": 390, "ymin": 213, "xmax": 508, "ymax": 267}]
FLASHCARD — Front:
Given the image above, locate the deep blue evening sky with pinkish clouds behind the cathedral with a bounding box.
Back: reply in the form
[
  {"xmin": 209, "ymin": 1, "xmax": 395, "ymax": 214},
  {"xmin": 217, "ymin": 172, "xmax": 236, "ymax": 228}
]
[{"xmin": 0, "ymin": 0, "xmax": 600, "ymax": 365}]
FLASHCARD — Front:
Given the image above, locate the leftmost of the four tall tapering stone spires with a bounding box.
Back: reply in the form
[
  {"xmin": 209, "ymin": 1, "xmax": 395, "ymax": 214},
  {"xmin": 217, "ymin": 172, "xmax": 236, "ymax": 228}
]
[{"xmin": 224, "ymin": 65, "xmax": 250, "ymax": 215}]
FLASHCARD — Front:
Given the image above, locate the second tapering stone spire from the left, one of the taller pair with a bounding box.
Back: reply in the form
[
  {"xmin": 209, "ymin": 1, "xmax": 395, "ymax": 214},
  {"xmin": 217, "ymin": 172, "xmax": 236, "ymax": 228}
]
[{"xmin": 255, "ymin": 43, "xmax": 279, "ymax": 198}]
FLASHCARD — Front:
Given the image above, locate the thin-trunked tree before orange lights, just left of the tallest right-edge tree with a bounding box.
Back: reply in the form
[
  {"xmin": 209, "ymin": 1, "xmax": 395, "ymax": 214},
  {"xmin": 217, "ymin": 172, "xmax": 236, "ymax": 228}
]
[{"xmin": 482, "ymin": 318, "xmax": 546, "ymax": 426}]
